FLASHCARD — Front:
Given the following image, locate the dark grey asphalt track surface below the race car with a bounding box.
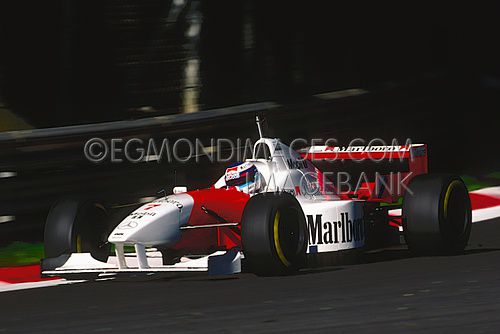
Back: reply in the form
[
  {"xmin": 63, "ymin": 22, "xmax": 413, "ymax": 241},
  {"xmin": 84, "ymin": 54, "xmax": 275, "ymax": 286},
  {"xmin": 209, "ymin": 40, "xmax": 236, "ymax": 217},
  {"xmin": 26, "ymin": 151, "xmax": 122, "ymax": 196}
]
[{"xmin": 0, "ymin": 219, "xmax": 500, "ymax": 334}]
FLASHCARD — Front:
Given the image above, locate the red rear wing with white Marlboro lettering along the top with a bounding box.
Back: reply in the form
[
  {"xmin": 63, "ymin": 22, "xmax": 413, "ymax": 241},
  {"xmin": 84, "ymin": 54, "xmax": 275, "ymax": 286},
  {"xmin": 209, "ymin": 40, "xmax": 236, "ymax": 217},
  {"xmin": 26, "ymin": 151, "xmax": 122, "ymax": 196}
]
[{"xmin": 298, "ymin": 144, "xmax": 428, "ymax": 202}]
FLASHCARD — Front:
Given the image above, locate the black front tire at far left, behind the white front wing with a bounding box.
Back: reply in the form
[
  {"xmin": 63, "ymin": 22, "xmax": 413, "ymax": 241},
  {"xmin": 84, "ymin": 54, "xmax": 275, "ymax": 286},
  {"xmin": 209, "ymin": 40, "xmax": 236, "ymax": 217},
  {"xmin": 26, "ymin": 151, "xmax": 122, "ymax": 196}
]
[{"xmin": 44, "ymin": 199, "xmax": 111, "ymax": 262}]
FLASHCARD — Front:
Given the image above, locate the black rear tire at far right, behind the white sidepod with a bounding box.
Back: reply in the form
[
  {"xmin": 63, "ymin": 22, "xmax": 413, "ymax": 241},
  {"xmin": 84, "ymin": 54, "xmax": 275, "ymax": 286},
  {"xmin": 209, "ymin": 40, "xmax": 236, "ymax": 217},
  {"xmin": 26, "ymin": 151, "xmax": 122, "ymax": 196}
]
[{"xmin": 403, "ymin": 174, "xmax": 472, "ymax": 255}]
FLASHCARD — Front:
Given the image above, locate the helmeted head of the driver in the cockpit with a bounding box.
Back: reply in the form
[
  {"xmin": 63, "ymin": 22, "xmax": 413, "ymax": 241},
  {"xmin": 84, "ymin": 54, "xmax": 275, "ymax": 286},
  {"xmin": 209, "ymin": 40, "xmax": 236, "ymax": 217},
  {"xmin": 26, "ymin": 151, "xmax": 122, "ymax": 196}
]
[{"xmin": 224, "ymin": 162, "xmax": 260, "ymax": 193}]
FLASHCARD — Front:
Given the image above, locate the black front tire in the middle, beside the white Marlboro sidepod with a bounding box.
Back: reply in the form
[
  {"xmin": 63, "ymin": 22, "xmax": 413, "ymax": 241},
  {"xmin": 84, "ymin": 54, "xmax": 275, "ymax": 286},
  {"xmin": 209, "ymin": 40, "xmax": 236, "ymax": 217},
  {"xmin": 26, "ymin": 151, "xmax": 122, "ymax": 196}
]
[{"xmin": 241, "ymin": 193, "xmax": 307, "ymax": 276}]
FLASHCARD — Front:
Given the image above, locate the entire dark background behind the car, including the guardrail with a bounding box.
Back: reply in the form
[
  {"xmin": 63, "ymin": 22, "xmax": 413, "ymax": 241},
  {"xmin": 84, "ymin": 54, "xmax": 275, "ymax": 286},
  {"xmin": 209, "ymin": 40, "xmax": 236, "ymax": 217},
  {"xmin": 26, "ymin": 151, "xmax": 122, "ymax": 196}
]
[{"xmin": 0, "ymin": 0, "xmax": 500, "ymax": 252}]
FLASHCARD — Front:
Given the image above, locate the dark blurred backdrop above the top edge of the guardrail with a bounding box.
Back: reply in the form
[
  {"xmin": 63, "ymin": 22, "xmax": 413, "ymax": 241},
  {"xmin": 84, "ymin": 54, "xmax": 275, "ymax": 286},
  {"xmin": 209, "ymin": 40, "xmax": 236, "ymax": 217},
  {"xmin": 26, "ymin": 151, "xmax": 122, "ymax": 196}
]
[{"xmin": 0, "ymin": 0, "xmax": 500, "ymax": 125}]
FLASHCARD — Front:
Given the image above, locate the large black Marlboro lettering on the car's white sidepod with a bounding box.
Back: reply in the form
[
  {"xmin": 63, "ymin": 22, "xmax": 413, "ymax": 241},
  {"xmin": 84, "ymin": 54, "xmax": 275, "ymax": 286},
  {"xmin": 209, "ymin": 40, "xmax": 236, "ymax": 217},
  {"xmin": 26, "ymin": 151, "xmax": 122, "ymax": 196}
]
[{"xmin": 307, "ymin": 212, "xmax": 365, "ymax": 245}]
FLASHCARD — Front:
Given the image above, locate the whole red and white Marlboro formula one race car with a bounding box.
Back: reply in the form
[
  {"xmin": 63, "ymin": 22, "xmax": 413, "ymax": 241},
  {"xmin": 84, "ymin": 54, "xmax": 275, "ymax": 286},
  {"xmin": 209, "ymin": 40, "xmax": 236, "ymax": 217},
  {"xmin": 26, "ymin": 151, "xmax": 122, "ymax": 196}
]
[{"xmin": 42, "ymin": 118, "xmax": 472, "ymax": 277}]
